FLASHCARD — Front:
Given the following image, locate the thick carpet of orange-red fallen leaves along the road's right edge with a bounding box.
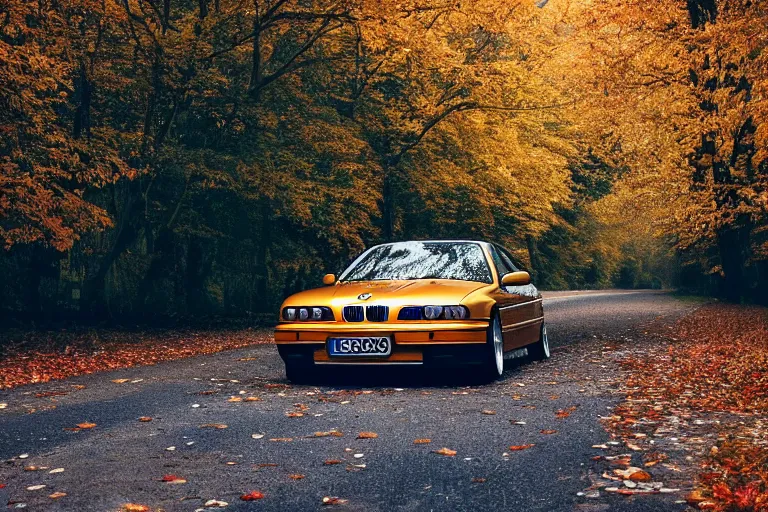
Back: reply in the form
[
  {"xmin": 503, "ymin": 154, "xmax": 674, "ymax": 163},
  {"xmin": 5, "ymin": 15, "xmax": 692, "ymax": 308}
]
[{"xmin": 625, "ymin": 304, "xmax": 768, "ymax": 512}]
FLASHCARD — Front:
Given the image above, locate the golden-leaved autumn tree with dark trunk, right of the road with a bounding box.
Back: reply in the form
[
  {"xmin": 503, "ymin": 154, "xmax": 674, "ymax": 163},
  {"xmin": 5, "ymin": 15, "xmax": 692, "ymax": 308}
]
[{"xmin": 578, "ymin": 0, "xmax": 768, "ymax": 300}]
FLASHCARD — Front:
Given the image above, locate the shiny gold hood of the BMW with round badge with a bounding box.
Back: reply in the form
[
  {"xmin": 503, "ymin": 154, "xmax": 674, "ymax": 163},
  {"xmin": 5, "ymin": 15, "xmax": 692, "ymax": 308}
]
[{"xmin": 283, "ymin": 279, "xmax": 488, "ymax": 307}]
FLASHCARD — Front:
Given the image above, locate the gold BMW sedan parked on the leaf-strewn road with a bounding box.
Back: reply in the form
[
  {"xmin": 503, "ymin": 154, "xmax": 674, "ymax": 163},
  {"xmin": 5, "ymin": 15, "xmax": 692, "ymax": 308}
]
[{"xmin": 275, "ymin": 240, "xmax": 549, "ymax": 382}]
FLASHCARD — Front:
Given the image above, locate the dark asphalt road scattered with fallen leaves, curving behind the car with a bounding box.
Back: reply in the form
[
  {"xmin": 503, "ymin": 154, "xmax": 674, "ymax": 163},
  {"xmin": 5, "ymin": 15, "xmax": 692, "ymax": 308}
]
[{"xmin": 0, "ymin": 292, "xmax": 690, "ymax": 511}]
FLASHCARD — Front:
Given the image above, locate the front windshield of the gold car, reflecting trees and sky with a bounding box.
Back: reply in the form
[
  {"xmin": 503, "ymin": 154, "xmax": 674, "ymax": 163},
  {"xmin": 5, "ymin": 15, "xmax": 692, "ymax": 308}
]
[{"xmin": 340, "ymin": 242, "xmax": 493, "ymax": 283}]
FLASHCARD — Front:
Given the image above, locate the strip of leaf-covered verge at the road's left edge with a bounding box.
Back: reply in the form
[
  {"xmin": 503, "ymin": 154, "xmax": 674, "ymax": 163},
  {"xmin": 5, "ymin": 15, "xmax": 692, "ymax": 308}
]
[{"xmin": 0, "ymin": 329, "xmax": 272, "ymax": 389}]
